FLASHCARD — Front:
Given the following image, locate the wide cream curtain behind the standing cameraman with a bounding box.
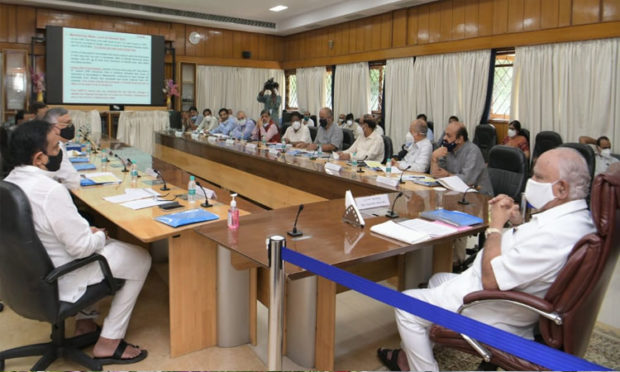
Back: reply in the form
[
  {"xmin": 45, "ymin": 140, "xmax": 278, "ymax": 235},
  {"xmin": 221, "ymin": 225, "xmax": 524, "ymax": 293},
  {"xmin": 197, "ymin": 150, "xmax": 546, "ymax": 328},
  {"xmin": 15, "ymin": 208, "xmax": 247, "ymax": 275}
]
[{"xmin": 196, "ymin": 66, "xmax": 286, "ymax": 119}]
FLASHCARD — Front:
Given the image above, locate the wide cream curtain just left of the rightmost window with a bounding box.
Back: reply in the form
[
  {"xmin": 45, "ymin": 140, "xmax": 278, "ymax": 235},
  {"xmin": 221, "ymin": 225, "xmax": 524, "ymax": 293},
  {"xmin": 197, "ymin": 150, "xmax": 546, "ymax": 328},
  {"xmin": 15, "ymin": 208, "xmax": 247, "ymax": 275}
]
[{"xmin": 411, "ymin": 50, "xmax": 491, "ymax": 141}]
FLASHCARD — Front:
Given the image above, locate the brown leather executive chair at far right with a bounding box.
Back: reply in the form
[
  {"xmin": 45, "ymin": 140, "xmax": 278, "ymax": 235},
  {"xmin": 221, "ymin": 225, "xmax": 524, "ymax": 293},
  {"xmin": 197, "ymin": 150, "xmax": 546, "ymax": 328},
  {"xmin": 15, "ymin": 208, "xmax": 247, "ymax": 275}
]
[{"xmin": 430, "ymin": 163, "xmax": 620, "ymax": 370}]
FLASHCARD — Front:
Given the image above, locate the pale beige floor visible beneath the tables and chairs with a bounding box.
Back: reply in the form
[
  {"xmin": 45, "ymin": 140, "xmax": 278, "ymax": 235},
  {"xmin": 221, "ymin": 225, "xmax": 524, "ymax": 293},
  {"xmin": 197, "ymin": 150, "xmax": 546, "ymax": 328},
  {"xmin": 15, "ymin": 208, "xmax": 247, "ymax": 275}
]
[{"xmin": 0, "ymin": 264, "xmax": 620, "ymax": 371}]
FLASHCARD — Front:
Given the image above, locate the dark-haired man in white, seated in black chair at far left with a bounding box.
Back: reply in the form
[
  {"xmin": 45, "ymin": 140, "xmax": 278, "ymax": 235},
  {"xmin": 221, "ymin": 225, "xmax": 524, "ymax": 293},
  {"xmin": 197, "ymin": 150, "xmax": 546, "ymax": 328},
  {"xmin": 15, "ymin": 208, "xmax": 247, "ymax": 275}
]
[{"xmin": 5, "ymin": 121, "xmax": 151, "ymax": 364}]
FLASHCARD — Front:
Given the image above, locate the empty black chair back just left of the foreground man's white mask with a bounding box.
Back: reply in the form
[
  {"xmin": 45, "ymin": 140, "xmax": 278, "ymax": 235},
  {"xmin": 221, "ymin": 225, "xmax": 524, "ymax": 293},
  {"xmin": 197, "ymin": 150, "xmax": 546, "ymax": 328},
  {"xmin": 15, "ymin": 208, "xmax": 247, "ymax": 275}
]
[{"xmin": 487, "ymin": 145, "xmax": 529, "ymax": 202}]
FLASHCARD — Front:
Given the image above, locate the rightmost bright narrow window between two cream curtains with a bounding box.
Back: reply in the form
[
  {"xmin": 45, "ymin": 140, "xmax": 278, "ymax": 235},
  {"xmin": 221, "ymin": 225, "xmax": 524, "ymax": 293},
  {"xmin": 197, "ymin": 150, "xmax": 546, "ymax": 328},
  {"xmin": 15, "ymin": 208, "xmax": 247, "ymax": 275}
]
[{"xmin": 491, "ymin": 51, "xmax": 515, "ymax": 120}]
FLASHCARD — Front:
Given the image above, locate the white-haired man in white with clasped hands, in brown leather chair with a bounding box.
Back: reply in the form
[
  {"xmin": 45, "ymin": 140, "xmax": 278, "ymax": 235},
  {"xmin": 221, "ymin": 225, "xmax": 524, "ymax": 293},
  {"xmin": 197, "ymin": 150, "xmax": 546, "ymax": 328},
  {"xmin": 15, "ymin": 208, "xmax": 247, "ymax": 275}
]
[{"xmin": 378, "ymin": 148, "xmax": 596, "ymax": 371}]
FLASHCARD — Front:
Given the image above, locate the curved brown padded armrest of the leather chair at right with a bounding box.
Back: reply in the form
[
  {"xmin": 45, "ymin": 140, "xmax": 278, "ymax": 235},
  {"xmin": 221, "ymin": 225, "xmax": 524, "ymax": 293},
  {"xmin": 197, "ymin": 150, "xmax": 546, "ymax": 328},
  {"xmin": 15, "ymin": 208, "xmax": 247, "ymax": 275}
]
[{"xmin": 458, "ymin": 290, "xmax": 562, "ymax": 325}]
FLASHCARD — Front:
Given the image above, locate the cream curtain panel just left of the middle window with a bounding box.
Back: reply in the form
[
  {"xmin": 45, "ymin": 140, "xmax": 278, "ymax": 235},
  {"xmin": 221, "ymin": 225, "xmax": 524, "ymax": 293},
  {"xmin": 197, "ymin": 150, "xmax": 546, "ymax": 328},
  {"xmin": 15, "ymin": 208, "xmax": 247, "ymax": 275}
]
[{"xmin": 334, "ymin": 62, "xmax": 370, "ymax": 118}]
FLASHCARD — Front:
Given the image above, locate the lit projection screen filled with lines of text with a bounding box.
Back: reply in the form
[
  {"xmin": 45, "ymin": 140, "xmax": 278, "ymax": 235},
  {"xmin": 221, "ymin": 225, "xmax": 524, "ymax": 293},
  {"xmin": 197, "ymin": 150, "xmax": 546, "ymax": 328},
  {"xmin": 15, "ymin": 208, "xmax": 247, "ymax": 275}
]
[{"xmin": 63, "ymin": 28, "xmax": 151, "ymax": 105}]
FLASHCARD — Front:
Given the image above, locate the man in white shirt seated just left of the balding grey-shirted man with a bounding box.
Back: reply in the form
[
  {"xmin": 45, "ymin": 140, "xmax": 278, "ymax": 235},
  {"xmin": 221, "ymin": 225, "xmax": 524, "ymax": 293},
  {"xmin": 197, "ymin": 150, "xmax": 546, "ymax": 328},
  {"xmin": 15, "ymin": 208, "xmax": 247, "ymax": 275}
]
[{"xmin": 392, "ymin": 119, "xmax": 433, "ymax": 173}]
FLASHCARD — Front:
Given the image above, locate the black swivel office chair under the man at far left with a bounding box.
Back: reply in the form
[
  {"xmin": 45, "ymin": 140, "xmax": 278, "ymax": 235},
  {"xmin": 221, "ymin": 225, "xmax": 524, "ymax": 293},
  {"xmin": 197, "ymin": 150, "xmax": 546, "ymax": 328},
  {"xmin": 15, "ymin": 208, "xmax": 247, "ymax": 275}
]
[{"xmin": 0, "ymin": 181, "xmax": 125, "ymax": 371}]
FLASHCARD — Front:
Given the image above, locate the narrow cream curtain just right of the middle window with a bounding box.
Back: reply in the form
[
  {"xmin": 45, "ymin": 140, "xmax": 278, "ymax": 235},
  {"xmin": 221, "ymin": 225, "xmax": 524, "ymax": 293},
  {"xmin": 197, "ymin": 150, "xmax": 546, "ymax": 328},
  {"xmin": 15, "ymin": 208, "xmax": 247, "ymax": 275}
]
[{"xmin": 385, "ymin": 57, "xmax": 416, "ymax": 148}]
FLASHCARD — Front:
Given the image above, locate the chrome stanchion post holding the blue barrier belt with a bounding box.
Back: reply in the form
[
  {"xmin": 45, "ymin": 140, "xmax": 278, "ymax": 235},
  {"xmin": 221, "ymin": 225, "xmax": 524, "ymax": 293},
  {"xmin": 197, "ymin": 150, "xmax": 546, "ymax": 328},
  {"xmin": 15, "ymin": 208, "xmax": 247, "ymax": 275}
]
[{"xmin": 267, "ymin": 235, "xmax": 286, "ymax": 371}]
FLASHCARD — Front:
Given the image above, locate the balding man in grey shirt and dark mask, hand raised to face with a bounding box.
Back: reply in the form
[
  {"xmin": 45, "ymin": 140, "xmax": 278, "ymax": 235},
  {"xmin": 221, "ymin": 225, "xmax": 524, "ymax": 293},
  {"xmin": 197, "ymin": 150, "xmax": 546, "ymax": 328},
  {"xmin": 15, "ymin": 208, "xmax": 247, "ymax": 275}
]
[{"xmin": 431, "ymin": 122, "xmax": 493, "ymax": 195}]
